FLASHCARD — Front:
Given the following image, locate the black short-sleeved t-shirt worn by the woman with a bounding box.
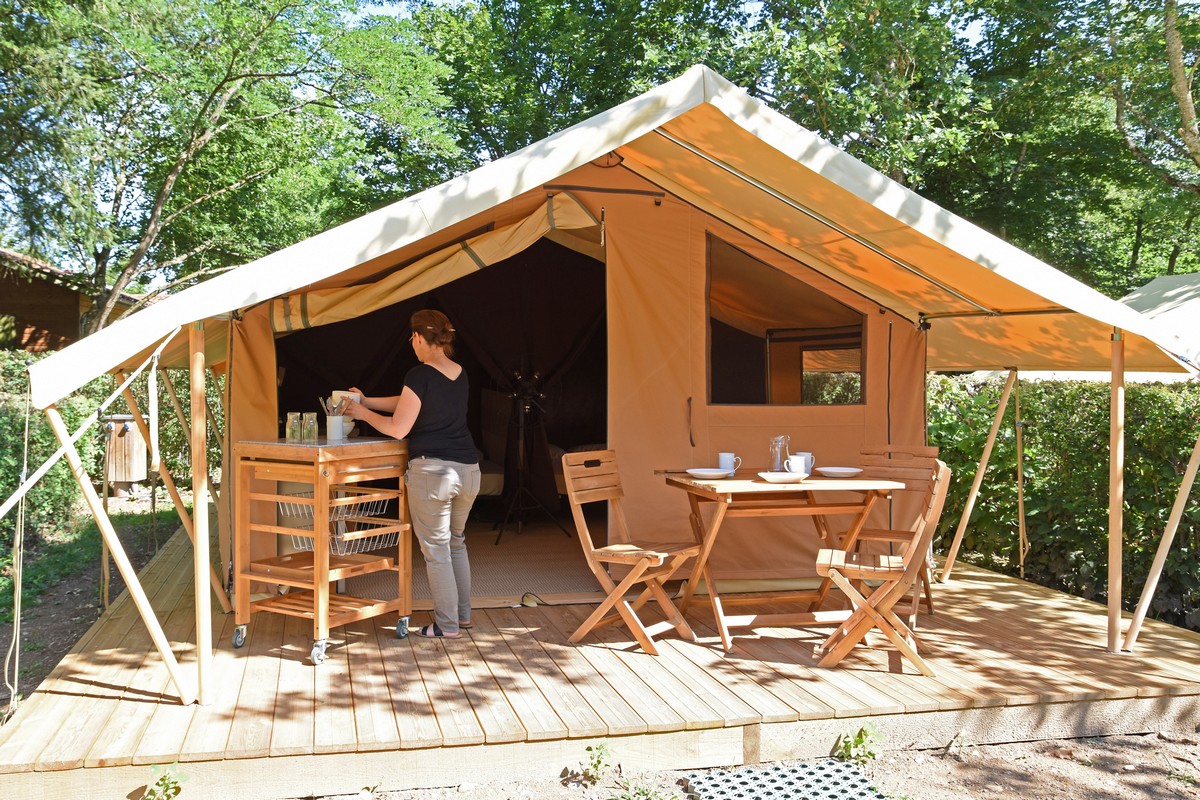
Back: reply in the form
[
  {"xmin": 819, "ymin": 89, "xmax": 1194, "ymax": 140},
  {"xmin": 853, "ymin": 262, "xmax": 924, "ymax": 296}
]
[{"xmin": 404, "ymin": 363, "xmax": 479, "ymax": 464}]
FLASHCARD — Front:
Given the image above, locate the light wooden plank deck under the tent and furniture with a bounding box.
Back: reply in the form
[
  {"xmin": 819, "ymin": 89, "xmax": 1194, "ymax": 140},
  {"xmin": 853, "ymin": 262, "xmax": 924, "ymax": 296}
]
[{"xmin": 0, "ymin": 525, "xmax": 1200, "ymax": 798}]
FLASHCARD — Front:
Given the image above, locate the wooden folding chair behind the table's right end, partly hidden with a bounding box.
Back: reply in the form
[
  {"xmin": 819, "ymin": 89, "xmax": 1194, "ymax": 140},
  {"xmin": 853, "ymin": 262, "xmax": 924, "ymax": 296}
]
[{"xmin": 858, "ymin": 445, "xmax": 941, "ymax": 627}]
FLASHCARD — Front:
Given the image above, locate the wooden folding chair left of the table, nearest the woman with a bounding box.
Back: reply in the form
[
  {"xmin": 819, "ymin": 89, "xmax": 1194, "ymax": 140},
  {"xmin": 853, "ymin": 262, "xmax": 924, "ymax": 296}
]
[{"xmin": 563, "ymin": 450, "xmax": 701, "ymax": 656}]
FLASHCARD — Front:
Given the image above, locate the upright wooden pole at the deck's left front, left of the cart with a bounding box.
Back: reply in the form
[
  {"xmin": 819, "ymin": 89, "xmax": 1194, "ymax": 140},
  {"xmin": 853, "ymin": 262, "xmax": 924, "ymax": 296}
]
[{"xmin": 187, "ymin": 321, "xmax": 220, "ymax": 705}]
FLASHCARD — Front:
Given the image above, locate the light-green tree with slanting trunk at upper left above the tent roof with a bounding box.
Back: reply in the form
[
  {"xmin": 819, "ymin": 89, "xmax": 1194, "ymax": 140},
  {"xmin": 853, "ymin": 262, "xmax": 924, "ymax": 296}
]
[{"xmin": 0, "ymin": 0, "xmax": 457, "ymax": 332}]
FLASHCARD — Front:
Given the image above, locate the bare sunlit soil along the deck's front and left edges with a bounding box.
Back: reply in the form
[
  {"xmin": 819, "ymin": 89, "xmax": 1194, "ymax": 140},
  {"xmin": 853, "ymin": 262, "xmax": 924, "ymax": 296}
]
[{"xmin": 0, "ymin": 493, "xmax": 1200, "ymax": 800}]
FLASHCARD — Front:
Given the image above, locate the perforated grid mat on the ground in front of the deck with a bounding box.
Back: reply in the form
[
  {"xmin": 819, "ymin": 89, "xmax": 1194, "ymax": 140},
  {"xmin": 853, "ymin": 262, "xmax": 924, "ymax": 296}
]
[{"xmin": 683, "ymin": 759, "xmax": 887, "ymax": 800}]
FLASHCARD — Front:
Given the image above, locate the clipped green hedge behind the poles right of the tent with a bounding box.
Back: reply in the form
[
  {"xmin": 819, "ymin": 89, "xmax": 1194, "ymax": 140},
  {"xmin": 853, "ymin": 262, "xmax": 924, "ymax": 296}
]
[{"xmin": 929, "ymin": 377, "xmax": 1200, "ymax": 628}]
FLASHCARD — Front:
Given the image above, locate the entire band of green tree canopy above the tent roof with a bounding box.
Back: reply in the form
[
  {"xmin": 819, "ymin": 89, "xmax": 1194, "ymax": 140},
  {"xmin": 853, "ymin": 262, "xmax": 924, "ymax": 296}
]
[{"xmin": 0, "ymin": 0, "xmax": 1200, "ymax": 329}]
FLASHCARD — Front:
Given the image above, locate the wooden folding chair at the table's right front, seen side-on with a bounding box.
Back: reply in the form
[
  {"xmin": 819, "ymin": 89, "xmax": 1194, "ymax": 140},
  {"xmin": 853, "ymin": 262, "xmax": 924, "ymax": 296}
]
[{"xmin": 817, "ymin": 461, "xmax": 950, "ymax": 678}]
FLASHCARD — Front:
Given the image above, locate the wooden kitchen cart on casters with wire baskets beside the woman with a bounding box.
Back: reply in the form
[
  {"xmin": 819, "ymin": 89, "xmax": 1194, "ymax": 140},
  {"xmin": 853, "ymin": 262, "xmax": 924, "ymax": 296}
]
[{"xmin": 233, "ymin": 438, "xmax": 413, "ymax": 664}]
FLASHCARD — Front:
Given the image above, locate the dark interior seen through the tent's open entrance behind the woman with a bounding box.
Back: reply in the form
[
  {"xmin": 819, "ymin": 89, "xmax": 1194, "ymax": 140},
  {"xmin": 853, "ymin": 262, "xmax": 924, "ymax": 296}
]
[{"xmin": 276, "ymin": 239, "xmax": 607, "ymax": 522}]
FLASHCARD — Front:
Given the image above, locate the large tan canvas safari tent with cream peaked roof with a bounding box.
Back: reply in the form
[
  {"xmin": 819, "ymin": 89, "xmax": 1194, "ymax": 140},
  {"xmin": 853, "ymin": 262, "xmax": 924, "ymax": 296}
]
[{"xmin": 11, "ymin": 66, "xmax": 1200, "ymax": 705}]
